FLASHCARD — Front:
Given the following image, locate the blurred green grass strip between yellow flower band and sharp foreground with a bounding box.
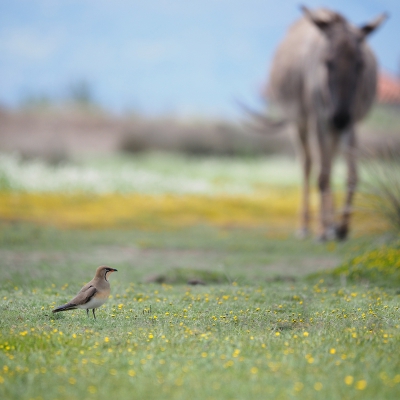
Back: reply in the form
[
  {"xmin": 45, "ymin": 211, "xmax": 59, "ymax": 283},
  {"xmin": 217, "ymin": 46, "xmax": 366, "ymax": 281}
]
[{"xmin": 0, "ymin": 222, "xmax": 366, "ymax": 288}]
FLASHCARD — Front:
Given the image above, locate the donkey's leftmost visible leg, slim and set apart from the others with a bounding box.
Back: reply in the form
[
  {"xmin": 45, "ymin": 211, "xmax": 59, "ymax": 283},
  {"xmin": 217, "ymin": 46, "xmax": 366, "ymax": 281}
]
[{"xmin": 298, "ymin": 123, "xmax": 312, "ymax": 238}]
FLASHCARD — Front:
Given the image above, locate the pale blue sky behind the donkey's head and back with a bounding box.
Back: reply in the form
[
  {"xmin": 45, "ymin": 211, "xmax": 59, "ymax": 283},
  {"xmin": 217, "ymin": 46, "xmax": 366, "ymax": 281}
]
[{"xmin": 0, "ymin": 0, "xmax": 400, "ymax": 117}]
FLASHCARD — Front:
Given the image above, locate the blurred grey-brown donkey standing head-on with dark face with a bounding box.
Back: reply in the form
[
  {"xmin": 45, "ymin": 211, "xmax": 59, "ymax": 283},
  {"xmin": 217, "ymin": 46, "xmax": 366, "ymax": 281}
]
[{"xmin": 268, "ymin": 7, "xmax": 387, "ymax": 240}]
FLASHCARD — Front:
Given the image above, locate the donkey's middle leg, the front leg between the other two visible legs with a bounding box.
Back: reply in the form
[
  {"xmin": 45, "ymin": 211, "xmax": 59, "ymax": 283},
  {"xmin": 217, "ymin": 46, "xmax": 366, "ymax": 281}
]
[{"xmin": 317, "ymin": 125, "xmax": 339, "ymax": 240}]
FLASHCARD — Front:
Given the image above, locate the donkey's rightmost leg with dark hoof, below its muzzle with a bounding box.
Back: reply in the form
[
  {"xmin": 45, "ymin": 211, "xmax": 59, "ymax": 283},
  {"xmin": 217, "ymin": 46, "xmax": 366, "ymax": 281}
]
[{"xmin": 336, "ymin": 128, "xmax": 358, "ymax": 240}]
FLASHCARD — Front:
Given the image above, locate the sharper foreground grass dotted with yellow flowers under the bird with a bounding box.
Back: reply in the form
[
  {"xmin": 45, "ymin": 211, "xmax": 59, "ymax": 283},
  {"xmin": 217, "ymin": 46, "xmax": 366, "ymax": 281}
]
[{"xmin": 0, "ymin": 284, "xmax": 400, "ymax": 399}]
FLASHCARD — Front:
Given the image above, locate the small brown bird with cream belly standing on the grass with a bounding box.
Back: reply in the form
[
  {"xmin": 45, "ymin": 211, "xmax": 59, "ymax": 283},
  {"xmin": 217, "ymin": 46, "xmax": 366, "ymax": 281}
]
[{"xmin": 52, "ymin": 265, "xmax": 117, "ymax": 319}]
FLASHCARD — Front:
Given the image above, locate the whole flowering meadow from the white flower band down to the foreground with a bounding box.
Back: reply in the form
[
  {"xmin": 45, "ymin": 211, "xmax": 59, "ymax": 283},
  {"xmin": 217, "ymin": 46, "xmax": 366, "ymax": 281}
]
[{"xmin": 0, "ymin": 154, "xmax": 400, "ymax": 400}]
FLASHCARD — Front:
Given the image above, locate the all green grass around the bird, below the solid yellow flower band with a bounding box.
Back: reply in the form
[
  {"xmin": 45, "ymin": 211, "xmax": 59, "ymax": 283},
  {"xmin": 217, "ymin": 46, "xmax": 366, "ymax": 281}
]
[{"xmin": 0, "ymin": 223, "xmax": 400, "ymax": 399}]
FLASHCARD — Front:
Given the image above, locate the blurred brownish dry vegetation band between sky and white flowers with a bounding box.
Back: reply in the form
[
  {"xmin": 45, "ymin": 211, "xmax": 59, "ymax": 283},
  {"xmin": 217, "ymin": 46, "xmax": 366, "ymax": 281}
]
[{"xmin": 0, "ymin": 105, "xmax": 400, "ymax": 163}]
